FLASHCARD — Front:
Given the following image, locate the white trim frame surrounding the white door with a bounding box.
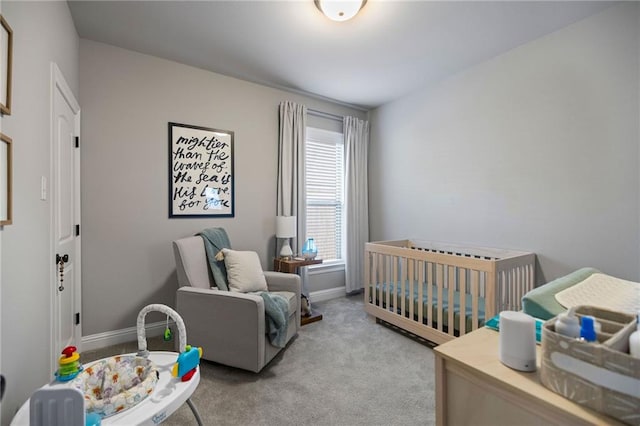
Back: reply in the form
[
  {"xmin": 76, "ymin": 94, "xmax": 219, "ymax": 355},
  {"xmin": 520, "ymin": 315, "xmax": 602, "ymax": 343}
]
[{"xmin": 48, "ymin": 62, "xmax": 82, "ymax": 373}]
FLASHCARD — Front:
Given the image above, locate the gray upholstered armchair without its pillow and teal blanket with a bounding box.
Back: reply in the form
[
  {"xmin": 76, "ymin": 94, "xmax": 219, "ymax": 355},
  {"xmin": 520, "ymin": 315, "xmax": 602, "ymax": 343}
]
[{"xmin": 173, "ymin": 236, "xmax": 301, "ymax": 373}]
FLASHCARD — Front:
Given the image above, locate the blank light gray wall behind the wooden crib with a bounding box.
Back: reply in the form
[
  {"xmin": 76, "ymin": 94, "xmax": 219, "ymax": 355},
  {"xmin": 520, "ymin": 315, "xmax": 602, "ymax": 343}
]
[{"xmin": 369, "ymin": 3, "xmax": 640, "ymax": 282}]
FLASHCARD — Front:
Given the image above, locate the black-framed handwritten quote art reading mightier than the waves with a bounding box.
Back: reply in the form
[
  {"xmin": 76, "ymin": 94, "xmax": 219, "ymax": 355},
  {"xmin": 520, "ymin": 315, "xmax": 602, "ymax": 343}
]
[{"xmin": 169, "ymin": 123, "xmax": 234, "ymax": 218}]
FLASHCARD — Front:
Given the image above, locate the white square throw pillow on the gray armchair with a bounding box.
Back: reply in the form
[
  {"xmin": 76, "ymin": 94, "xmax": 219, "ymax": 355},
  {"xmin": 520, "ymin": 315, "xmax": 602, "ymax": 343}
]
[{"xmin": 222, "ymin": 249, "xmax": 267, "ymax": 293}]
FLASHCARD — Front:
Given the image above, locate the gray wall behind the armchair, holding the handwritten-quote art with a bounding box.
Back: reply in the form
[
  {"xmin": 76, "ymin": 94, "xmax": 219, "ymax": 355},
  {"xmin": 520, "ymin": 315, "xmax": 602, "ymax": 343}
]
[{"xmin": 80, "ymin": 39, "xmax": 365, "ymax": 336}]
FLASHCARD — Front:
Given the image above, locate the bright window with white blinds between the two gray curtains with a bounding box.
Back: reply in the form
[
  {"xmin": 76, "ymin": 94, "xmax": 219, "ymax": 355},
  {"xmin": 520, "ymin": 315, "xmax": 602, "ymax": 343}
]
[{"xmin": 305, "ymin": 127, "xmax": 344, "ymax": 263}]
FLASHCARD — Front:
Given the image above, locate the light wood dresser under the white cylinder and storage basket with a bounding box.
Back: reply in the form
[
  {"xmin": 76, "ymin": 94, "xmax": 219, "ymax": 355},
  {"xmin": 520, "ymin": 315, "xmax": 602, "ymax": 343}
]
[{"xmin": 434, "ymin": 328, "xmax": 622, "ymax": 426}]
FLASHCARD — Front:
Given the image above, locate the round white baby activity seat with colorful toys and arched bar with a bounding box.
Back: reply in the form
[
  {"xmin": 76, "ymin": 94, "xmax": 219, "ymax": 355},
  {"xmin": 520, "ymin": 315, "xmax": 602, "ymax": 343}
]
[{"xmin": 12, "ymin": 304, "xmax": 204, "ymax": 426}]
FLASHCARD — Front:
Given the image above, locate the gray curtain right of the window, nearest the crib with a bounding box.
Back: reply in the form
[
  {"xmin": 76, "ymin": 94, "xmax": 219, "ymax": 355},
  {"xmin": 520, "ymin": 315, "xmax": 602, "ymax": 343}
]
[{"xmin": 344, "ymin": 117, "xmax": 369, "ymax": 293}]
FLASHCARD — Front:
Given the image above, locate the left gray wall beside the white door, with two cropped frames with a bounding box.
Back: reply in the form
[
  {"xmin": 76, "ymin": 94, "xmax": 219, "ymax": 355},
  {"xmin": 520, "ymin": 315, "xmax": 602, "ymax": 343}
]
[{"xmin": 0, "ymin": 2, "xmax": 79, "ymax": 425}]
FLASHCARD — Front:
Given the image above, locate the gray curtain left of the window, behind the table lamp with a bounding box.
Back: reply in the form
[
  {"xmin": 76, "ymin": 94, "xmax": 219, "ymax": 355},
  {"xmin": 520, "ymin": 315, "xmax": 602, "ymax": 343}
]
[{"xmin": 276, "ymin": 101, "xmax": 309, "ymax": 296}]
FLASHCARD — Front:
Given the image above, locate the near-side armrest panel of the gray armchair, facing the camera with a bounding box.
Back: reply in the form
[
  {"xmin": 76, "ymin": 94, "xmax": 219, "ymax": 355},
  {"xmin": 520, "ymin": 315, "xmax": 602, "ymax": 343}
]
[{"xmin": 176, "ymin": 287, "xmax": 265, "ymax": 372}]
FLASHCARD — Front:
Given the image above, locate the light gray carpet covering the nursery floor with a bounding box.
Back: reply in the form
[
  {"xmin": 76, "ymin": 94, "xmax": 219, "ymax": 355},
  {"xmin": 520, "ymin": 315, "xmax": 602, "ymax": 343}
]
[{"xmin": 83, "ymin": 295, "xmax": 435, "ymax": 426}]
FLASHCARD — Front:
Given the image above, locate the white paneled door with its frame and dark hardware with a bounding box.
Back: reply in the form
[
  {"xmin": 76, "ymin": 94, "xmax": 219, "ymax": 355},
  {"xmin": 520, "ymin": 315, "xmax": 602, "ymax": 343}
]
[{"xmin": 50, "ymin": 63, "xmax": 82, "ymax": 370}]
